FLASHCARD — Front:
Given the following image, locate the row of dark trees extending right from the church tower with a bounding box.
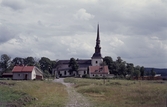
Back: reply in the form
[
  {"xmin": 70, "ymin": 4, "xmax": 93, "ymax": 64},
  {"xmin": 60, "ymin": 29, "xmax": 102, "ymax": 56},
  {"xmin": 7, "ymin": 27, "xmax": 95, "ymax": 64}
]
[{"xmin": 102, "ymin": 56, "xmax": 156, "ymax": 78}]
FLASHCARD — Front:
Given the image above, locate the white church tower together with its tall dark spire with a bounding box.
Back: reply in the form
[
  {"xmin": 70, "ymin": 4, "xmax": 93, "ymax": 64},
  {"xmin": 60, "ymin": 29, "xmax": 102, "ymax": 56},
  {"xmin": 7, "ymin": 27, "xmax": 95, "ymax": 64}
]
[{"xmin": 92, "ymin": 24, "xmax": 103, "ymax": 66}]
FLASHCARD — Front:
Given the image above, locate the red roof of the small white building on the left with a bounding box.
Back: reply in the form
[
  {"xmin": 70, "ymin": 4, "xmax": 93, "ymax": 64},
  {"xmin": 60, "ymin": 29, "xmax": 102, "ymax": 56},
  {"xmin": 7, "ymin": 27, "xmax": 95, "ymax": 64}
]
[{"xmin": 12, "ymin": 66, "xmax": 34, "ymax": 72}]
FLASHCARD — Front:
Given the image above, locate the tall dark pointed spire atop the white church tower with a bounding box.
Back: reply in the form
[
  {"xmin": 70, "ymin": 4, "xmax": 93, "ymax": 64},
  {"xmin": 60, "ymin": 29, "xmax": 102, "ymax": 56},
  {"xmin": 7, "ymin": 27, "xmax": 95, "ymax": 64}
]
[{"xmin": 92, "ymin": 24, "xmax": 102, "ymax": 58}]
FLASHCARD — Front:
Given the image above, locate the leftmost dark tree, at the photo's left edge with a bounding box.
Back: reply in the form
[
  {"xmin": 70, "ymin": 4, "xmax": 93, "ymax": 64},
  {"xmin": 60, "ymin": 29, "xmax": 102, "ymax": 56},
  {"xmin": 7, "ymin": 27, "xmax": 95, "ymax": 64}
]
[{"xmin": 0, "ymin": 54, "xmax": 11, "ymax": 72}]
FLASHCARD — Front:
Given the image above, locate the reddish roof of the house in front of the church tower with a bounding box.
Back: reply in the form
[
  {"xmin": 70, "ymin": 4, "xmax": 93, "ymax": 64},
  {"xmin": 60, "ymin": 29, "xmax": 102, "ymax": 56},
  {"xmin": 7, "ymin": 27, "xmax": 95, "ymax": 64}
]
[{"xmin": 89, "ymin": 66, "xmax": 109, "ymax": 74}]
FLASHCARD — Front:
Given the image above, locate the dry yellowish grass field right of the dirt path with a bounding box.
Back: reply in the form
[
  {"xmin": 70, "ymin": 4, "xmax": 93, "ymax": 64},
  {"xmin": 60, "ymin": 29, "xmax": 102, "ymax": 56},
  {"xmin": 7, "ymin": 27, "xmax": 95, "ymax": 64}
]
[{"xmin": 65, "ymin": 78, "xmax": 167, "ymax": 107}]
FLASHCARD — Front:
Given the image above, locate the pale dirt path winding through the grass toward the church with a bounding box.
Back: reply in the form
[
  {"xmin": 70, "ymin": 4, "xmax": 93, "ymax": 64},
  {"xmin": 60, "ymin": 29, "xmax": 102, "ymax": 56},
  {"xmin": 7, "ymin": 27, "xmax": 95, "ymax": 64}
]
[{"xmin": 54, "ymin": 78, "xmax": 90, "ymax": 107}]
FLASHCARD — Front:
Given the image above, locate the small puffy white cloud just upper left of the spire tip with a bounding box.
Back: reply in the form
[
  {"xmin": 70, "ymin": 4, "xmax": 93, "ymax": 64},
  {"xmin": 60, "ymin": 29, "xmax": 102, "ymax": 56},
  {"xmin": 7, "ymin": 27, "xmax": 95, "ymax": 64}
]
[{"xmin": 74, "ymin": 8, "xmax": 94, "ymax": 20}]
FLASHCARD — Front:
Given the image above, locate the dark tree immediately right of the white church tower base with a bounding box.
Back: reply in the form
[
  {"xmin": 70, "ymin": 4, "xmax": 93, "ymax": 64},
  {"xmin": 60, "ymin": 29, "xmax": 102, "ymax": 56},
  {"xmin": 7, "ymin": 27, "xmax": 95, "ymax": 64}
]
[{"xmin": 103, "ymin": 56, "xmax": 114, "ymax": 74}]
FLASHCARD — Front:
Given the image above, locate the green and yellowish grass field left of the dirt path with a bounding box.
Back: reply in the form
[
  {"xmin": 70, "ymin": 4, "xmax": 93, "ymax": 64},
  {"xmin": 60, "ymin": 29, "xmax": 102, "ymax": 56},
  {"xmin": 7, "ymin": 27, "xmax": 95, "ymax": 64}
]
[{"xmin": 0, "ymin": 80, "xmax": 68, "ymax": 107}]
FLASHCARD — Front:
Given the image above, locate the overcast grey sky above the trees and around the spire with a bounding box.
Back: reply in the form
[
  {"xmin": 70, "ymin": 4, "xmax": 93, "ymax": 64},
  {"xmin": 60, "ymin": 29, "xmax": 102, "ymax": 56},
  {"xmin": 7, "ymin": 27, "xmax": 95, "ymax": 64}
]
[{"xmin": 0, "ymin": 0, "xmax": 167, "ymax": 68}]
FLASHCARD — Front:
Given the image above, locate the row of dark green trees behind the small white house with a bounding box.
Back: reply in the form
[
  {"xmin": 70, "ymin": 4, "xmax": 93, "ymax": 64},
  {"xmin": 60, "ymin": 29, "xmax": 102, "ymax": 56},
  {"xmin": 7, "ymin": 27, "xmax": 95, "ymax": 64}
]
[{"xmin": 0, "ymin": 54, "xmax": 56, "ymax": 77}]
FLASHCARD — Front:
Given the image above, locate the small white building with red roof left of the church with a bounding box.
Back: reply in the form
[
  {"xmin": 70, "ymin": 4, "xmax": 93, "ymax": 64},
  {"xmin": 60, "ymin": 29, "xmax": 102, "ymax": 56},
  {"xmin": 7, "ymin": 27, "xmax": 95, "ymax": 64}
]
[{"xmin": 12, "ymin": 66, "xmax": 43, "ymax": 80}]
